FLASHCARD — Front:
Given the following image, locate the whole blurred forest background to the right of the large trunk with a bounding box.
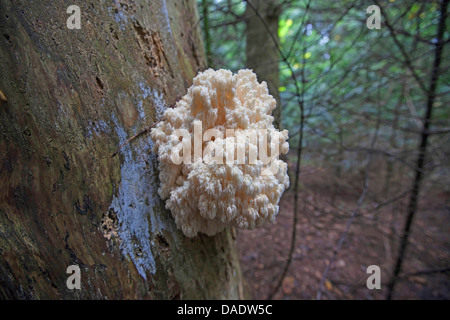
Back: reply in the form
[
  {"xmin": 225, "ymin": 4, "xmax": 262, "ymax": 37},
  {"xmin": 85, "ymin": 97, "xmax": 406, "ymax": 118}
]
[{"xmin": 197, "ymin": 0, "xmax": 450, "ymax": 299}]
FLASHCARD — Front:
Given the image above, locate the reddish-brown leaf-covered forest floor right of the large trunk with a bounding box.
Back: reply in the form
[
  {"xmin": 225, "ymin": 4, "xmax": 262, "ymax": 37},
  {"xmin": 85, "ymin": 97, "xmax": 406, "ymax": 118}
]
[{"xmin": 237, "ymin": 167, "xmax": 450, "ymax": 300}]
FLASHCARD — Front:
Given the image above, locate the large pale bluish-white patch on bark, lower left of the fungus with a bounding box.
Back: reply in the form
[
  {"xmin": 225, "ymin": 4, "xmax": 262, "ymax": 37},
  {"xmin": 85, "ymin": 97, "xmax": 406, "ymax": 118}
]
[{"xmin": 110, "ymin": 115, "xmax": 164, "ymax": 279}]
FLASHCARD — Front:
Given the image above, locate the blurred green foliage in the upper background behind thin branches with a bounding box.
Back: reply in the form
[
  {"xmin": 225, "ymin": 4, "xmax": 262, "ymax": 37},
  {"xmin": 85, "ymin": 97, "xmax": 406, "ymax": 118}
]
[{"xmin": 199, "ymin": 0, "xmax": 450, "ymax": 174}]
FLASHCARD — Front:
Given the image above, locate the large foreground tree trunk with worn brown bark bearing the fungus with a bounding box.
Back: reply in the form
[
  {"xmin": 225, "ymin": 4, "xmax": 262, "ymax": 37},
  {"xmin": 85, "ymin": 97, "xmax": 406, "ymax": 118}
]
[{"xmin": 0, "ymin": 0, "xmax": 246, "ymax": 299}]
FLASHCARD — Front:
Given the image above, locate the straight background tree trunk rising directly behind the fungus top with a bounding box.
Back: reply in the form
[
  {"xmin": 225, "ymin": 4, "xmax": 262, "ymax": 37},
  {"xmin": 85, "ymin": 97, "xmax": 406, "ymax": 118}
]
[{"xmin": 245, "ymin": 0, "xmax": 282, "ymax": 129}]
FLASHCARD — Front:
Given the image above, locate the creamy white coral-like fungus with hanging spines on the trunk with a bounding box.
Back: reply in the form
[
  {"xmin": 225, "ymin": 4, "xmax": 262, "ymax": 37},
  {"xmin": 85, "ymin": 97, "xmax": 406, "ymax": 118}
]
[{"xmin": 151, "ymin": 69, "xmax": 289, "ymax": 237}]
